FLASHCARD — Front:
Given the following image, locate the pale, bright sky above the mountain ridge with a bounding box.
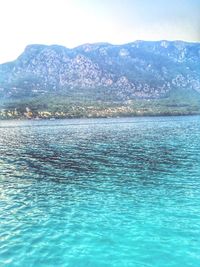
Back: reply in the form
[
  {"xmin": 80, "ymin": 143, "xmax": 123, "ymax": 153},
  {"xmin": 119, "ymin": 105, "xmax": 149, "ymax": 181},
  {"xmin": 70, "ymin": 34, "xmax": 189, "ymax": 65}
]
[{"xmin": 0, "ymin": 0, "xmax": 200, "ymax": 63}]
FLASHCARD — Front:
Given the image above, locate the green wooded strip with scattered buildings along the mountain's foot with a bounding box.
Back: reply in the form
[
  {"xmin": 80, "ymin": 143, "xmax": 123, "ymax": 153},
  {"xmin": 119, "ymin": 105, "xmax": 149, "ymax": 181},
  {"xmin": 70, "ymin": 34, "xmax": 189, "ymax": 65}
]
[{"xmin": 0, "ymin": 90, "xmax": 200, "ymax": 119}]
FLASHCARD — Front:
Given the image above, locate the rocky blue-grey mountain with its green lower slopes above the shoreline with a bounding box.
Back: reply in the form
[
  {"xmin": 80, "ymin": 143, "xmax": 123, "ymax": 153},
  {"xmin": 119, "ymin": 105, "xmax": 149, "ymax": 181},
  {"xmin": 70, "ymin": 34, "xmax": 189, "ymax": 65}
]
[{"xmin": 0, "ymin": 41, "xmax": 200, "ymax": 116}]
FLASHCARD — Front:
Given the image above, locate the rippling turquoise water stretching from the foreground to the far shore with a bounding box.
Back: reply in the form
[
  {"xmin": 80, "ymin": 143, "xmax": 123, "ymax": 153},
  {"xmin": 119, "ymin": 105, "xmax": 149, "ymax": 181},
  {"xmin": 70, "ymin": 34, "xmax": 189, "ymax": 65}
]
[{"xmin": 0, "ymin": 116, "xmax": 200, "ymax": 267}]
